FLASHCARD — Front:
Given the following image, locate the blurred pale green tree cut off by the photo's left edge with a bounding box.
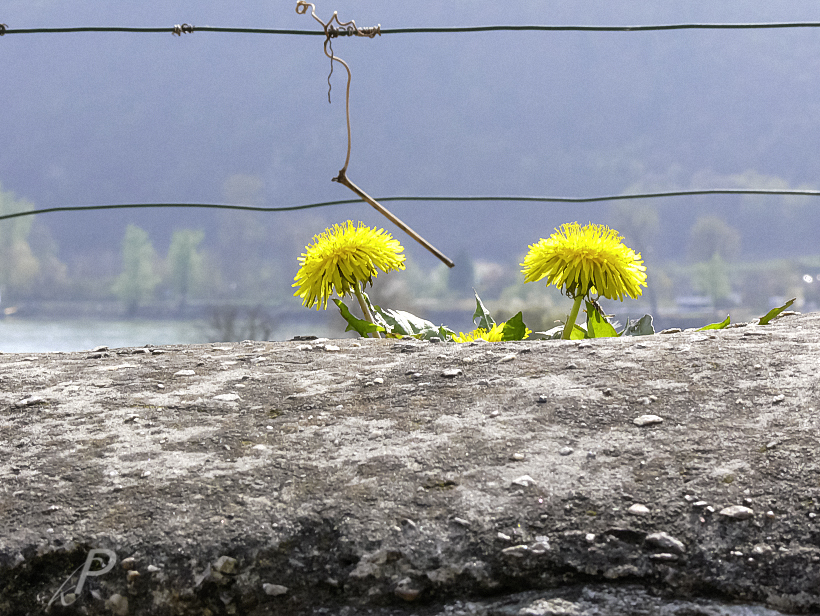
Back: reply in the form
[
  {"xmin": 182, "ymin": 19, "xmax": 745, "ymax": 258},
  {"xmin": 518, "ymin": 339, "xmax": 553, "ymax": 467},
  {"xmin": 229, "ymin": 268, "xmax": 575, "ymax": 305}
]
[{"xmin": 0, "ymin": 186, "xmax": 40, "ymax": 294}]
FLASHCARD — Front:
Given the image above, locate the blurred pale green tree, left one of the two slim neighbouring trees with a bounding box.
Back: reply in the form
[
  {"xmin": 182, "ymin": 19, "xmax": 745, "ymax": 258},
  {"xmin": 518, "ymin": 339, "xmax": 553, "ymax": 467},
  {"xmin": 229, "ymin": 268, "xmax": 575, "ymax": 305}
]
[{"xmin": 112, "ymin": 225, "xmax": 160, "ymax": 316}]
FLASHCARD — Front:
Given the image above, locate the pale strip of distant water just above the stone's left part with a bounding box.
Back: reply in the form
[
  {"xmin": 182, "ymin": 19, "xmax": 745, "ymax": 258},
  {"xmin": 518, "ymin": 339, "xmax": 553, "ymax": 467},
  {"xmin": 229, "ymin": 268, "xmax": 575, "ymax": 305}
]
[{"xmin": 0, "ymin": 319, "xmax": 346, "ymax": 353}]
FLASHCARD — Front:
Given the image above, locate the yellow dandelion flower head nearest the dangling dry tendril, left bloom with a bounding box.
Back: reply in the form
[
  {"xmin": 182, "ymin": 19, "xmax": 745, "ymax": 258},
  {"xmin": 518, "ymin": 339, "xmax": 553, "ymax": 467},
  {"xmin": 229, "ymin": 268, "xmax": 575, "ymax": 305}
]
[{"xmin": 292, "ymin": 220, "xmax": 405, "ymax": 310}]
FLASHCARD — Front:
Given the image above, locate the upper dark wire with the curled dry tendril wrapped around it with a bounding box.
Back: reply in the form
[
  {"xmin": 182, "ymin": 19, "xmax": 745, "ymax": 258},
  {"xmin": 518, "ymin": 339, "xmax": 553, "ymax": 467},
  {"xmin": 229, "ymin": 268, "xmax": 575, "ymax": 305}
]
[{"xmin": 8, "ymin": 21, "xmax": 820, "ymax": 36}]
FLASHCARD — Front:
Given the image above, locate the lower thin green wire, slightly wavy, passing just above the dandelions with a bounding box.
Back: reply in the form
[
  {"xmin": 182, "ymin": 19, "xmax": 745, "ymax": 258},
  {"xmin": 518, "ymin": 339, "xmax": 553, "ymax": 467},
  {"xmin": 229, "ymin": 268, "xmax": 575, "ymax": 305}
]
[{"xmin": 0, "ymin": 188, "xmax": 820, "ymax": 221}]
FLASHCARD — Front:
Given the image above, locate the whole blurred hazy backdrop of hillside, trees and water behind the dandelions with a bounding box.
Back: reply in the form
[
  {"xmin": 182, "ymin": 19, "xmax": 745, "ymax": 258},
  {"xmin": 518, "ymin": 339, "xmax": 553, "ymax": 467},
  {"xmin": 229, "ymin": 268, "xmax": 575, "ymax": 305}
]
[{"xmin": 0, "ymin": 0, "xmax": 820, "ymax": 352}]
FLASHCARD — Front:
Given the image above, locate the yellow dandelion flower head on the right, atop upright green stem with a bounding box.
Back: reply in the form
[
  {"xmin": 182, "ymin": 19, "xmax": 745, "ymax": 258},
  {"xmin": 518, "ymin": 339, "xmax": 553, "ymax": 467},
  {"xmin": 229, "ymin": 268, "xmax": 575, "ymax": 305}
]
[{"xmin": 521, "ymin": 222, "xmax": 646, "ymax": 301}]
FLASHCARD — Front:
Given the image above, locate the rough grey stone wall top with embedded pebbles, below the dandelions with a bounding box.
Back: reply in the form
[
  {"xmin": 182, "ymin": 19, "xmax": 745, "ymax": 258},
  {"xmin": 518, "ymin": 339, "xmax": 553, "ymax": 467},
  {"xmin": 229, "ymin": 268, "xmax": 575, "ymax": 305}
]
[{"xmin": 0, "ymin": 314, "xmax": 820, "ymax": 616}]
